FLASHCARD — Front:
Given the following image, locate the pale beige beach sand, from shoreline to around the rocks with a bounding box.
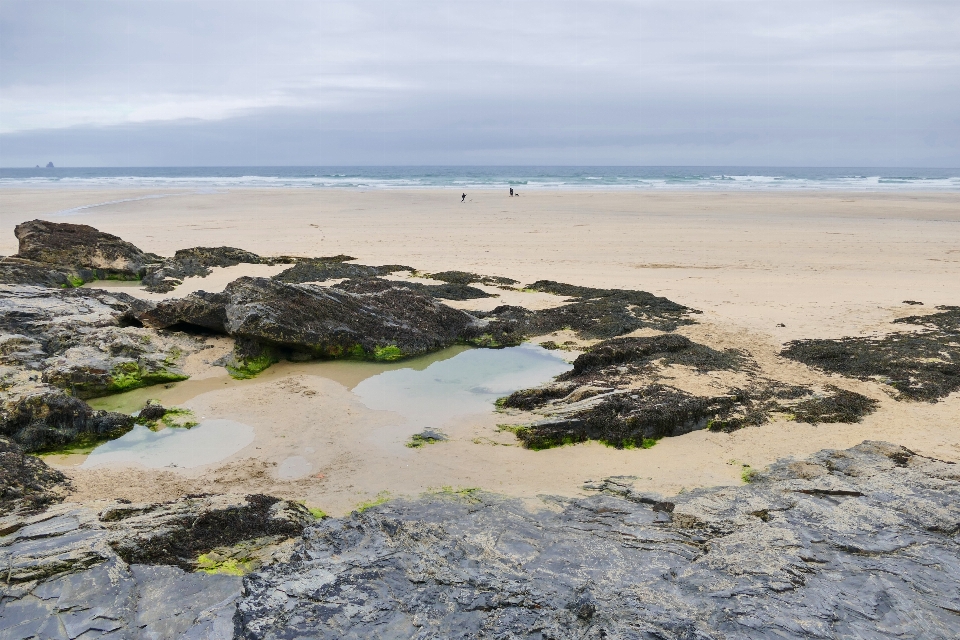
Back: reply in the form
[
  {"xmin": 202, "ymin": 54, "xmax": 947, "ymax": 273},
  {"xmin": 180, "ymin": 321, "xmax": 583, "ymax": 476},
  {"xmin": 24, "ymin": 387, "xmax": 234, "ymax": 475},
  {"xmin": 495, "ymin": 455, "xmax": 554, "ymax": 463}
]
[{"xmin": 0, "ymin": 189, "xmax": 960, "ymax": 512}]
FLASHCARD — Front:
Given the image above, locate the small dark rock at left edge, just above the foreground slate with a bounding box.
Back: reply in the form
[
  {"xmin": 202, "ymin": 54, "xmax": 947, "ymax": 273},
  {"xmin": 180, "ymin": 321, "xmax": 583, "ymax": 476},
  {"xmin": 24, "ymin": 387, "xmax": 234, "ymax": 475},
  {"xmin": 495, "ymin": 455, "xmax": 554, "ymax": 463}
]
[{"xmin": 0, "ymin": 437, "xmax": 69, "ymax": 516}]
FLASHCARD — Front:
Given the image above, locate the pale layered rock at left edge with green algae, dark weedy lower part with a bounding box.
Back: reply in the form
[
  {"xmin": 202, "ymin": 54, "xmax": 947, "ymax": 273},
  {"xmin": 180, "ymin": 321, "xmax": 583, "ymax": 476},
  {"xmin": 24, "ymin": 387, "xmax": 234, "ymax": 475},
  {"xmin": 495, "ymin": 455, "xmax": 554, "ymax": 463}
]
[{"xmin": 0, "ymin": 285, "xmax": 203, "ymax": 451}]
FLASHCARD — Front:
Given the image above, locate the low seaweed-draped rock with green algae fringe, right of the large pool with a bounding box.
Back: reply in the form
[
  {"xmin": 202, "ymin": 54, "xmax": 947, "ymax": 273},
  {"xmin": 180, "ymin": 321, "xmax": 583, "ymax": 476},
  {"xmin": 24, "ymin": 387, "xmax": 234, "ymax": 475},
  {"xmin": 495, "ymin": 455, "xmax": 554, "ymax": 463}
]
[{"xmin": 499, "ymin": 333, "xmax": 879, "ymax": 449}]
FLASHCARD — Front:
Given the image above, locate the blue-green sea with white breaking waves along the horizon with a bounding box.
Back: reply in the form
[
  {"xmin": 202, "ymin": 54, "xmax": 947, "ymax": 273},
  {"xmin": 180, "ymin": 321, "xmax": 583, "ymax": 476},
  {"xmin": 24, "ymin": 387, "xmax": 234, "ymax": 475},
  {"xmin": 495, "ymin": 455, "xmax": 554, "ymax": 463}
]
[{"xmin": 0, "ymin": 166, "xmax": 960, "ymax": 192}]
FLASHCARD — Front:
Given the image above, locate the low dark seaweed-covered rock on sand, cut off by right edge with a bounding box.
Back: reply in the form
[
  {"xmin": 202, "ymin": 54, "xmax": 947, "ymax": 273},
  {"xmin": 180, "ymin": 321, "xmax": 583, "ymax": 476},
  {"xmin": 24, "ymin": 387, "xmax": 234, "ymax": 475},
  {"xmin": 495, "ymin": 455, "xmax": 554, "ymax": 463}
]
[{"xmin": 781, "ymin": 306, "xmax": 960, "ymax": 401}]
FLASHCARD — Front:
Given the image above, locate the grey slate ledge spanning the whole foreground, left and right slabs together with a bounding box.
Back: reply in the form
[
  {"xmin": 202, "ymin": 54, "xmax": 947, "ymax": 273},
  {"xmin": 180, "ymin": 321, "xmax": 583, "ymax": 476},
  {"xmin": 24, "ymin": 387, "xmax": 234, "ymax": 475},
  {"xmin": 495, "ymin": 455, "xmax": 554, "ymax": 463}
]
[{"xmin": 0, "ymin": 442, "xmax": 960, "ymax": 640}]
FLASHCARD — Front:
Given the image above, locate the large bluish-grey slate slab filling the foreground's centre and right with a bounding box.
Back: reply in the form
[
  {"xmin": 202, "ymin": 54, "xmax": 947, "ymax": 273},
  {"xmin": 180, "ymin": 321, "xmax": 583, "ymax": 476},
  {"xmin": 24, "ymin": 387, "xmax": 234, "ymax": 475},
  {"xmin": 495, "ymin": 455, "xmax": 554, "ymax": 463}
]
[{"xmin": 238, "ymin": 442, "xmax": 960, "ymax": 640}]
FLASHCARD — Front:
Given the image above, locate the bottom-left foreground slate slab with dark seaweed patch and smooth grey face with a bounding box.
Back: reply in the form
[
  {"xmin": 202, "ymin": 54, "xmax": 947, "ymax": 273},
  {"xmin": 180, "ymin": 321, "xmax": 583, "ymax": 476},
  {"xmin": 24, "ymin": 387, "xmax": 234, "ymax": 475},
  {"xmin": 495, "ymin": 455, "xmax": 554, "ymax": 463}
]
[{"xmin": 0, "ymin": 496, "xmax": 313, "ymax": 639}]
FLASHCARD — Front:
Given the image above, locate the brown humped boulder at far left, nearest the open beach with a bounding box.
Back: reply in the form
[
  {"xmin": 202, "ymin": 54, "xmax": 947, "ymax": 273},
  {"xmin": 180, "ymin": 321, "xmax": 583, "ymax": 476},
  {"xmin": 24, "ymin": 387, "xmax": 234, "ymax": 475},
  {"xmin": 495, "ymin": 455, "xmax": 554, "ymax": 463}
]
[{"xmin": 14, "ymin": 220, "xmax": 159, "ymax": 278}]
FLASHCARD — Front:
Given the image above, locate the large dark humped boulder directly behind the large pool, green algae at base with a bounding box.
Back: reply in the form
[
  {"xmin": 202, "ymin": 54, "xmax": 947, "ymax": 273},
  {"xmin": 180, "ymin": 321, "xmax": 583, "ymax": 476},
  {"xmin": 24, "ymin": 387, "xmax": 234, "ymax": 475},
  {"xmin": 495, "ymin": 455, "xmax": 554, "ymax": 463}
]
[{"xmin": 138, "ymin": 278, "xmax": 477, "ymax": 359}]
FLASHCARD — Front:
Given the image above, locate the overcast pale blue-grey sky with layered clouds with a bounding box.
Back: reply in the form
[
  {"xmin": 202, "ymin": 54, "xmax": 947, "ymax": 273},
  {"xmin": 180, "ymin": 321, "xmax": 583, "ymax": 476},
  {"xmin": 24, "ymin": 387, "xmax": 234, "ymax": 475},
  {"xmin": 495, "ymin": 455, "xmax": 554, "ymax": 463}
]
[{"xmin": 0, "ymin": 0, "xmax": 960, "ymax": 167}]
